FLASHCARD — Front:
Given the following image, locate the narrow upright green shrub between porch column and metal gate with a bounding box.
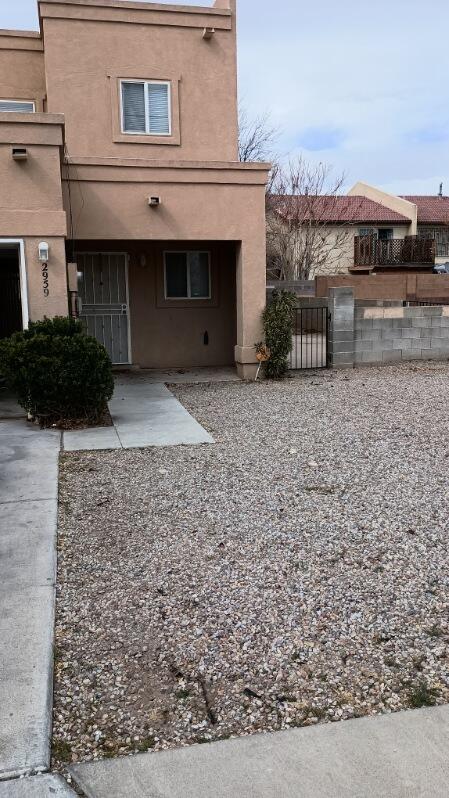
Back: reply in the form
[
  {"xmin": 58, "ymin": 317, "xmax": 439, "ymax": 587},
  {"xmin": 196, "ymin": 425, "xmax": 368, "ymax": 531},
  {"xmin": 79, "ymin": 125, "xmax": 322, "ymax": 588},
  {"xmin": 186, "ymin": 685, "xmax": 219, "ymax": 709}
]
[{"xmin": 262, "ymin": 290, "xmax": 296, "ymax": 379}]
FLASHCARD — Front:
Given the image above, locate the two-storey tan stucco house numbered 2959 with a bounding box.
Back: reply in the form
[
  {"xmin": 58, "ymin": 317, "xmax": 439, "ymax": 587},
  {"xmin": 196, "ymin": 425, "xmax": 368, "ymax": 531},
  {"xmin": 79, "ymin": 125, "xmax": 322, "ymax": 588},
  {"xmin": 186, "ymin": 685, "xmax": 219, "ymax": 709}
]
[{"xmin": 0, "ymin": 0, "xmax": 268, "ymax": 377}]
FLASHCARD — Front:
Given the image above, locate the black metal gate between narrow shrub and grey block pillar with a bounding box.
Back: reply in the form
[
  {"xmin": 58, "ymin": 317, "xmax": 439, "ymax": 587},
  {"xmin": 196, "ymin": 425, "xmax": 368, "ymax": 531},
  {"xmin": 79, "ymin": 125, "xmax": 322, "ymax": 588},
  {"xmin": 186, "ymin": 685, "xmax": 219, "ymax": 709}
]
[{"xmin": 290, "ymin": 305, "xmax": 329, "ymax": 370}]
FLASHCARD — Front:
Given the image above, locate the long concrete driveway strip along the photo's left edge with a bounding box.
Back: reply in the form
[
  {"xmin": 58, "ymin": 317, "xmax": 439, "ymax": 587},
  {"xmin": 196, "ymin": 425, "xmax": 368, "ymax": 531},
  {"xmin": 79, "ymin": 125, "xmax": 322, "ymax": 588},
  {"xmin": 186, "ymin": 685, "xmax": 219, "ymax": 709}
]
[{"xmin": 0, "ymin": 419, "xmax": 60, "ymax": 794}]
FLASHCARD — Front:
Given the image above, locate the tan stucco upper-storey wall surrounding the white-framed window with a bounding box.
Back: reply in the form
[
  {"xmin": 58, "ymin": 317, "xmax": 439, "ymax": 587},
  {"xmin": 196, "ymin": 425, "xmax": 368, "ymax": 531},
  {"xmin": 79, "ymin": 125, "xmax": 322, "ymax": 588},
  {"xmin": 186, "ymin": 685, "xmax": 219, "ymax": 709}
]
[{"xmin": 43, "ymin": 5, "xmax": 237, "ymax": 160}]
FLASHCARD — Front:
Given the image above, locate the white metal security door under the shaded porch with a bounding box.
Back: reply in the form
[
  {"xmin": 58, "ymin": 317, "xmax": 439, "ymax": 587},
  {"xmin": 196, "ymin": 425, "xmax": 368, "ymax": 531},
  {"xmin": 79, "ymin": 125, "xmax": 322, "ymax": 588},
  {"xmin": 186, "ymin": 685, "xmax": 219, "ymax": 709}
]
[{"xmin": 76, "ymin": 252, "xmax": 131, "ymax": 365}]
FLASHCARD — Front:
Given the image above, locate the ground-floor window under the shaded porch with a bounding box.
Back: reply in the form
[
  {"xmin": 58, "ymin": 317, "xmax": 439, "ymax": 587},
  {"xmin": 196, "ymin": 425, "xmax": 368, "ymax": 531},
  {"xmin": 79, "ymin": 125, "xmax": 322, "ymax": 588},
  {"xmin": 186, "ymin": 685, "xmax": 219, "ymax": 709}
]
[{"xmin": 164, "ymin": 250, "xmax": 211, "ymax": 299}]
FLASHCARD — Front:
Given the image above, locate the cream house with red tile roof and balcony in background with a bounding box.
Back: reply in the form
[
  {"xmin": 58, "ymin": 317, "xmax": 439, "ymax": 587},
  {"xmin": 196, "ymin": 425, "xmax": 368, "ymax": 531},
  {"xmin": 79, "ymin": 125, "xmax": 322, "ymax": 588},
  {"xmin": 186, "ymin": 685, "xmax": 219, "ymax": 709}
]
[{"xmin": 268, "ymin": 183, "xmax": 449, "ymax": 279}]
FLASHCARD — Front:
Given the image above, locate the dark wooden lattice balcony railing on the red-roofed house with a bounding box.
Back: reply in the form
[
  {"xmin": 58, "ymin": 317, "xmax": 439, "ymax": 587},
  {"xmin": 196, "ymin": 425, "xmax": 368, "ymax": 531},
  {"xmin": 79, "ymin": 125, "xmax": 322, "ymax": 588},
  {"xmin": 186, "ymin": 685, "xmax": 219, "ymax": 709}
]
[{"xmin": 354, "ymin": 236, "xmax": 435, "ymax": 268}]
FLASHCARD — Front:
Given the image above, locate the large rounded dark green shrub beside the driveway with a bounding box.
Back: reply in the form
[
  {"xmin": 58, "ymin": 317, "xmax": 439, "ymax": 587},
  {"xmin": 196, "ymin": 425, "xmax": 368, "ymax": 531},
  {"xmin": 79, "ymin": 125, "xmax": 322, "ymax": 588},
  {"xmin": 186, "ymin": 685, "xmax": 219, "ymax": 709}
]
[{"xmin": 0, "ymin": 316, "xmax": 114, "ymax": 424}]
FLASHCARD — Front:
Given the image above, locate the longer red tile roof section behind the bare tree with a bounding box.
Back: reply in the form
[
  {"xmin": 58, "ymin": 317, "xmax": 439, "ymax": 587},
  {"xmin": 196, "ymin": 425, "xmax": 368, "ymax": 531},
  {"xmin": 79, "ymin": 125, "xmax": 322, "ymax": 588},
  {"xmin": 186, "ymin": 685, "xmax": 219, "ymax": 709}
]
[{"xmin": 273, "ymin": 196, "xmax": 410, "ymax": 225}]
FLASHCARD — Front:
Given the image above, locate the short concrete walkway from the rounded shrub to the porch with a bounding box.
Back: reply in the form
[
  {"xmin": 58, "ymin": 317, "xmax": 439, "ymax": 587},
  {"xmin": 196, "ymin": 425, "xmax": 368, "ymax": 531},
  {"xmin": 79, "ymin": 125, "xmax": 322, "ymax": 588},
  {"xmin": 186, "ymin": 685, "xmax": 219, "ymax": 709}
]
[{"xmin": 64, "ymin": 374, "xmax": 214, "ymax": 452}]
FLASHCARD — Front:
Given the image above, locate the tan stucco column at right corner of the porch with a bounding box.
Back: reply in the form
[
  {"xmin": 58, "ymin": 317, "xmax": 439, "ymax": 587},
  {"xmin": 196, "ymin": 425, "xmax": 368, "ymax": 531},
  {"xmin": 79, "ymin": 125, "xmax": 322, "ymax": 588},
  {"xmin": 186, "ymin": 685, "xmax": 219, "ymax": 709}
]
[{"xmin": 235, "ymin": 231, "xmax": 266, "ymax": 380}]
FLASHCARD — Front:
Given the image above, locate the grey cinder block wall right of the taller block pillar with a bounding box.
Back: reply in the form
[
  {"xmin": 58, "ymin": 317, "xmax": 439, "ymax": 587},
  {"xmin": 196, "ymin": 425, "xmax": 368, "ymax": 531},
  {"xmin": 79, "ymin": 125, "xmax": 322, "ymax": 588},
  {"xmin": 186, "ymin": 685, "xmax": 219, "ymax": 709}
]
[{"xmin": 354, "ymin": 302, "xmax": 449, "ymax": 365}]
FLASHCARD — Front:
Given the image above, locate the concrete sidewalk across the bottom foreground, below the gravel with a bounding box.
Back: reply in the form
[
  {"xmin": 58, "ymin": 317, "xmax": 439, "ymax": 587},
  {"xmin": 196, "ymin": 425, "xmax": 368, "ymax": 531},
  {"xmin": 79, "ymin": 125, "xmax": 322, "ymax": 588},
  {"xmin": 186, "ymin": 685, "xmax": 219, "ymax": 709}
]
[{"xmin": 71, "ymin": 706, "xmax": 449, "ymax": 798}]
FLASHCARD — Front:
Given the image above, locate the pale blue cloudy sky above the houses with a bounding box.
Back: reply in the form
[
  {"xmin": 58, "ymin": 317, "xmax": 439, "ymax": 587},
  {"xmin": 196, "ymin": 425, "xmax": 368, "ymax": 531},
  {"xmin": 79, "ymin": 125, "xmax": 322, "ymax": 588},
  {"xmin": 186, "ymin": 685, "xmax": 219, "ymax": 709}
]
[{"xmin": 0, "ymin": 0, "xmax": 449, "ymax": 194}]
